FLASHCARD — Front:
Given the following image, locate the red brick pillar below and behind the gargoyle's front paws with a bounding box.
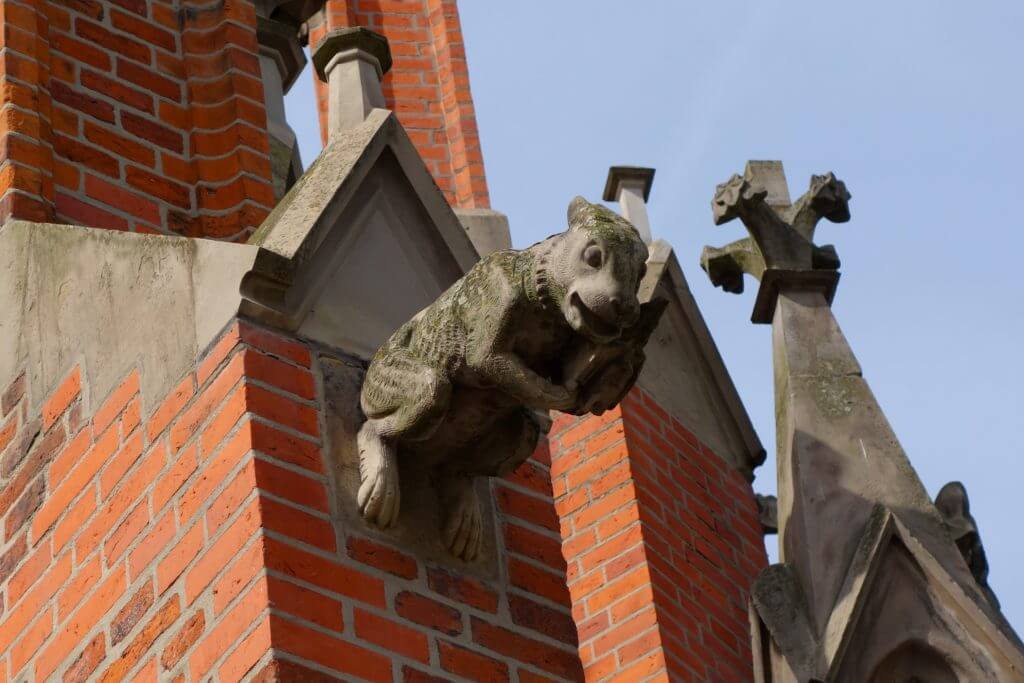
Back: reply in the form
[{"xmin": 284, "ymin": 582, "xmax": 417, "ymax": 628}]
[{"xmin": 551, "ymin": 388, "xmax": 767, "ymax": 682}]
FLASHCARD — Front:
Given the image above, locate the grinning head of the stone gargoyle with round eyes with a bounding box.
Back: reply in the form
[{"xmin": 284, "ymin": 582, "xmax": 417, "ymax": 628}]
[{"xmin": 548, "ymin": 197, "xmax": 647, "ymax": 343}]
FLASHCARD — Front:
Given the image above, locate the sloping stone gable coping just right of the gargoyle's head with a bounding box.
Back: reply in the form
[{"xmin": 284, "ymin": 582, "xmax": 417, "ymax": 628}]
[{"xmin": 639, "ymin": 240, "xmax": 765, "ymax": 481}]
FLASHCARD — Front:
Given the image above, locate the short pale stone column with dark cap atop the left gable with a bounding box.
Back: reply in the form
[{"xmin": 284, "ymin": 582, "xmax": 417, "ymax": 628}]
[{"xmin": 312, "ymin": 27, "xmax": 391, "ymax": 134}]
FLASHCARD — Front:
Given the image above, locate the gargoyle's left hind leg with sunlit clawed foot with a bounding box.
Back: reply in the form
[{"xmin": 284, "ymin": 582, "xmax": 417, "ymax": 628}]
[{"xmin": 356, "ymin": 348, "xmax": 452, "ymax": 528}]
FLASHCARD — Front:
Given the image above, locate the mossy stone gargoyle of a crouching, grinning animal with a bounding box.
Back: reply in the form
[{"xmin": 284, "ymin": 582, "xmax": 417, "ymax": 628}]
[{"xmin": 357, "ymin": 197, "xmax": 666, "ymax": 561}]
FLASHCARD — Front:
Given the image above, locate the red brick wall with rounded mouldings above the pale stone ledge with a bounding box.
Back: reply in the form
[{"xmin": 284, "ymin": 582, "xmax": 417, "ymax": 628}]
[{"xmin": 0, "ymin": 0, "xmax": 273, "ymax": 240}]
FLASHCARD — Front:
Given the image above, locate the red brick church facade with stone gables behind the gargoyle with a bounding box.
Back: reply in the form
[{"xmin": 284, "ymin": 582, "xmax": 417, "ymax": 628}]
[{"xmin": 0, "ymin": 0, "xmax": 1011, "ymax": 683}]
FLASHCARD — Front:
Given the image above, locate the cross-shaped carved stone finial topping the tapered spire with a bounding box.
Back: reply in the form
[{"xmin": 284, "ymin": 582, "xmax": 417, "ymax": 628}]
[{"xmin": 700, "ymin": 162, "xmax": 851, "ymax": 323}]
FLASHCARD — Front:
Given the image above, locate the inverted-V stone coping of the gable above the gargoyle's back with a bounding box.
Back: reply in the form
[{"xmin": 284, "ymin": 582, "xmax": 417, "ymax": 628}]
[{"xmin": 242, "ymin": 109, "xmax": 479, "ymax": 339}]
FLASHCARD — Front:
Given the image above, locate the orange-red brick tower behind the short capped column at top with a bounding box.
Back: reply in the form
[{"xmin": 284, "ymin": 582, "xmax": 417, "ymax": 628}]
[{"xmin": 309, "ymin": 0, "xmax": 490, "ymax": 208}]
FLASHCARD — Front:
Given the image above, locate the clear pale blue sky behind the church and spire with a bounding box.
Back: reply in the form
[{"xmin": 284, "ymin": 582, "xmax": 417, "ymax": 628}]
[{"xmin": 288, "ymin": 0, "xmax": 1024, "ymax": 631}]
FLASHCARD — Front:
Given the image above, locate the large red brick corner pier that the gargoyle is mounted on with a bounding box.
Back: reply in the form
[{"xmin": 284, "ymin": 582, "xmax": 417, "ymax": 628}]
[{"xmin": 0, "ymin": 324, "xmax": 581, "ymax": 682}]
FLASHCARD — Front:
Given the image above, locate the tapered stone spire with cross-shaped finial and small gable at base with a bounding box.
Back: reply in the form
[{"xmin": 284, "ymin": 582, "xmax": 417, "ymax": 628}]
[{"xmin": 701, "ymin": 162, "xmax": 1024, "ymax": 683}]
